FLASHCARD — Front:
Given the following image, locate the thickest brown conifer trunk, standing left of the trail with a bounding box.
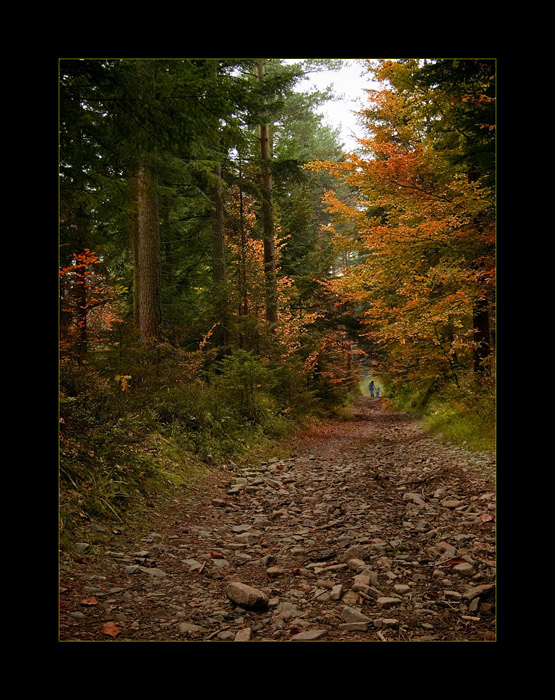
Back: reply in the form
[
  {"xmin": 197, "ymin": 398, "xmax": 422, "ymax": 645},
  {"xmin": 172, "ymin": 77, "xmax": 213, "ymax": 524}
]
[{"xmin": 131, "ymin": 165, "xmax": 162, "ymax": 341}]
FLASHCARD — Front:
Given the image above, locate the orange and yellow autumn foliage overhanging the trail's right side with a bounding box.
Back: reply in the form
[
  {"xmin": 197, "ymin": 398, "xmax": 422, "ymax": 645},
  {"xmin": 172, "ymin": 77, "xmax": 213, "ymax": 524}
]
[{"xmin": 309, "ymin": 61, "xmax": 495, "ymax": 388}]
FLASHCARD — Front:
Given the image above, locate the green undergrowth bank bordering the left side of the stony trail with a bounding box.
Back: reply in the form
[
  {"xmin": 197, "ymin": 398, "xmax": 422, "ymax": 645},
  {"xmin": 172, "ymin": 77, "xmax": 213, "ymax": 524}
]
[{"xmin": 59, "ymin": 350, "xmax": 360, "ymax": 530}]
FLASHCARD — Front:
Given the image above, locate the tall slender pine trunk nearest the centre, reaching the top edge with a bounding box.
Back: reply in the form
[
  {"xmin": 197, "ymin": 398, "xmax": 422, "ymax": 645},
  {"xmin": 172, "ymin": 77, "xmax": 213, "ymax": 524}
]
[{"xmin": 257, "ymin": 60, "xmax": 278, "ymax": 324}]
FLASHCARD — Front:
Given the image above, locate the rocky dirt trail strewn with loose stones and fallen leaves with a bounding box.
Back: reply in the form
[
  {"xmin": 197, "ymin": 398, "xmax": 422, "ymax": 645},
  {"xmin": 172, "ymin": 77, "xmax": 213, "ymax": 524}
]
[{"xmin": 59, "ymin": 399, "xmax": 495, "ymax": 643}]
